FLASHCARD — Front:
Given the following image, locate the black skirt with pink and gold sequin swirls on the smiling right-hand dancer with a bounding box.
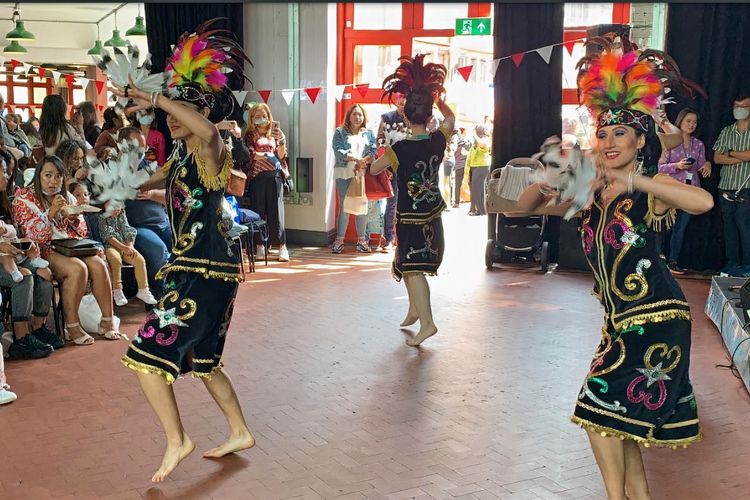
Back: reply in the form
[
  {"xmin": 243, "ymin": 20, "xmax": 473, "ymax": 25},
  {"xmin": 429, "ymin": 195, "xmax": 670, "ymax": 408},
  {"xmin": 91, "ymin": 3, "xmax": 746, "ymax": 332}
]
[{"xmin": 571, "ymin": 319, "xmax": 702, "ymax": 448}]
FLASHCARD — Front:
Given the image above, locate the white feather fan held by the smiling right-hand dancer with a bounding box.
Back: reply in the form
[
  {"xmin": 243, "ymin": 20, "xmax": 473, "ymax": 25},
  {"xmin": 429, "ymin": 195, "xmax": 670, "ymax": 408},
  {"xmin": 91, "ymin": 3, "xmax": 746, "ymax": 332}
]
[{"xmin": 534, "ymin": 144, "xmax": 596, "ymax": 220}]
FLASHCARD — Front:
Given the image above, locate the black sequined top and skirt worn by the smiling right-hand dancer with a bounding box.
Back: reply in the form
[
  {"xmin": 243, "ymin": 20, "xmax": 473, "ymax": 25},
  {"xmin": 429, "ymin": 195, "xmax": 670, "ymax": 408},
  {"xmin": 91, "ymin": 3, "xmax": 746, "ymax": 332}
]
[{"xmin": 572, "ymin": 185, "xmax": 701, "ymax": 446}]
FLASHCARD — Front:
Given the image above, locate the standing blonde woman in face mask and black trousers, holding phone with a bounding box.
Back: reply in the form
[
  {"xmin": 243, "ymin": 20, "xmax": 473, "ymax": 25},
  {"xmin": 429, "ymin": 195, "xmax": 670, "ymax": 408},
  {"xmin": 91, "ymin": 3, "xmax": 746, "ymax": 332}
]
[{"xmin": 245, "ymin": 103, "xmax": 289, "ymax": 262}]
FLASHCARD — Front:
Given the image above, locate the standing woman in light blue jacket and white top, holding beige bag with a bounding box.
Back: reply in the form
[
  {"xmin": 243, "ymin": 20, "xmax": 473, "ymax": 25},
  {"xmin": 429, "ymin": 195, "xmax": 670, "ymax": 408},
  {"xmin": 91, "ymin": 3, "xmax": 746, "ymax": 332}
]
[{"xmin": 331, "ymin": 104, "xmax": 376, "ymax": 253}]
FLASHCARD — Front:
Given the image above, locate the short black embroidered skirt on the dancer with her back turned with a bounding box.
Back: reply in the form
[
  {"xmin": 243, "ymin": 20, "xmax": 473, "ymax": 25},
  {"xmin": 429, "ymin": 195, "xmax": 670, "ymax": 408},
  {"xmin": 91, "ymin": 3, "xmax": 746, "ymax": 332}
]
[{"xmin": 393, "ymin": 216, "xmax": 445, "ymax": 281}]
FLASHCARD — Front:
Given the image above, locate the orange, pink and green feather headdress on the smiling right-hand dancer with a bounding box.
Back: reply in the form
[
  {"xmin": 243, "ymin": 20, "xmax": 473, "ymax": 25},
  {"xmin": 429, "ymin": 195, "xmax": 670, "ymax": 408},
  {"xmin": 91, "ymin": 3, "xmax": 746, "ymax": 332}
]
[{"xmin": 576, "ymin": 33, "xmax": 705, "ymax": 133}]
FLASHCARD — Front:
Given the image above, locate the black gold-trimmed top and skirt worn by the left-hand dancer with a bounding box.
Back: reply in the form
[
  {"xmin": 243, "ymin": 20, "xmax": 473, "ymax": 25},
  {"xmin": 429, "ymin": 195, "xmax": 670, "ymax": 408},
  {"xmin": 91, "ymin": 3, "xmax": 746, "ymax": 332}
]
[{"xmin": 122, "ymin": 145, "xmax": 241, "ymax": 384}]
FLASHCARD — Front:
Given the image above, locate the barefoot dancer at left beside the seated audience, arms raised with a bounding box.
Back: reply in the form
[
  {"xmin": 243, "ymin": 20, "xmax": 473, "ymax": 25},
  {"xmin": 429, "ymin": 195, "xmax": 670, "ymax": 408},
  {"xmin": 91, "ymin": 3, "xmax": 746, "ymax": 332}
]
[{"xmin": 108, "ymin": 21, "xmax": 255, "ymax": 482}]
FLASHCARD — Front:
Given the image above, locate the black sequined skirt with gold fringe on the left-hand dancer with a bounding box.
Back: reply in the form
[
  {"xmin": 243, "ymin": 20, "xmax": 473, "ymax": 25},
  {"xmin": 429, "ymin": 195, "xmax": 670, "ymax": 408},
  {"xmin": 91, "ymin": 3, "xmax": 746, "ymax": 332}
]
[{"xmin": 122, "ymin": 271, "xmax": 239, "ymax": 384}]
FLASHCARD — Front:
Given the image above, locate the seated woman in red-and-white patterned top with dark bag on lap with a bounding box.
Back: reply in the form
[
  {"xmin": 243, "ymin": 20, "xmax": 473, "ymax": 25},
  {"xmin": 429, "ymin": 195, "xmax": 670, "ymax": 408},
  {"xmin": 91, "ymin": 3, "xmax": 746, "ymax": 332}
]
[{"xmin": 13, "ymin": 156, "xmax": 120, "ymax": 345}]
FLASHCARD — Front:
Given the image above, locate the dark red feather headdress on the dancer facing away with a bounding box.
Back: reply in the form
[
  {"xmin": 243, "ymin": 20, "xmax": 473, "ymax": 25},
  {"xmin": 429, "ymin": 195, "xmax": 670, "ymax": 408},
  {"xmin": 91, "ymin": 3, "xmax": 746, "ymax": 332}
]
[{"xmin": 380, "ymin": 54, "xmax": 448, "ymax": 103}]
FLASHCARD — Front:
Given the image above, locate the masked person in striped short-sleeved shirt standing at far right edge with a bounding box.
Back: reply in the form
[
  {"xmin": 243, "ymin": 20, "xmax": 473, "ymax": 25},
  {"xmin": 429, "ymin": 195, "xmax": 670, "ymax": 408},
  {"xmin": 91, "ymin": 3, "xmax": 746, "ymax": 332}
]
[{"xmin": 714, "ymin": 92, "xmax": 750, "ymax": 276}]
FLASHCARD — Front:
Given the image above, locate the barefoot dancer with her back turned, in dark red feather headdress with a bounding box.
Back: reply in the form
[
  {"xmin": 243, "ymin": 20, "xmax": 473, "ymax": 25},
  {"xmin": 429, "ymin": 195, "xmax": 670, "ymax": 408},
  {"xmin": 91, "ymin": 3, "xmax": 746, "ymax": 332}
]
[{"xmin": 370, "ymin": 54, "xmax": 455, "ymax": 347}]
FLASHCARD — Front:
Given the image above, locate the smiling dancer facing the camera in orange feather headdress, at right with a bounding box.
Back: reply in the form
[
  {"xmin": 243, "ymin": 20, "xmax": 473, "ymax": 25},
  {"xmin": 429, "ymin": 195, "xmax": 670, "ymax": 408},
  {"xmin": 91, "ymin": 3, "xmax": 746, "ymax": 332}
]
[{"xmin": 519, "ymin": 45, "xmax": 713, "ymax": 500}]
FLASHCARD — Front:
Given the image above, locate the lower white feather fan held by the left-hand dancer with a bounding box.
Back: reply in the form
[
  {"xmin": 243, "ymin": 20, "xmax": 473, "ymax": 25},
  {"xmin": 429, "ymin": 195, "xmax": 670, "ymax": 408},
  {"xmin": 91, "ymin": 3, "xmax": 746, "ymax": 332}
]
[{"xmin": 89, "ymin": 140, "xmax": 157, "ymax": 216}]
